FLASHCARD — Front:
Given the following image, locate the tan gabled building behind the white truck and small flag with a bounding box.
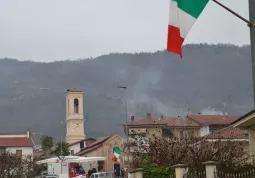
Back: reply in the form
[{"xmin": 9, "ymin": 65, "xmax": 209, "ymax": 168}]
[{"xmin": 75, "ymin": 134, "xmax": 124, "ymax": 171}]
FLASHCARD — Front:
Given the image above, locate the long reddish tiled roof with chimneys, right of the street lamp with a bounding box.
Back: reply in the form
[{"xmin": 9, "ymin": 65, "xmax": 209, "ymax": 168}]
[{"xmin": 129, "ymin": 117, "xmax": 200, "ymax": 127}]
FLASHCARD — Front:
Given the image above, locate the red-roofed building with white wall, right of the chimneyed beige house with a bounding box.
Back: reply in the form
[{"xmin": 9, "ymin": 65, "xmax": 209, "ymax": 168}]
[{"xmin": 187, "ymin": 114, "xmax": 239, "ymax": 137}]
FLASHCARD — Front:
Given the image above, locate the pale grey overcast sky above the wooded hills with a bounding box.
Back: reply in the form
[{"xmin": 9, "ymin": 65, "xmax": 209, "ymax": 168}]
[{"xmin": 0, "ymin": 0, "xmax": 249, "ymax": 62}]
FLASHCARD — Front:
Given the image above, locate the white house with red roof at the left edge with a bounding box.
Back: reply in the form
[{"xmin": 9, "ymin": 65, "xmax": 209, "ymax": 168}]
[{"xmin": 0, "ymin": 131, "xmax": 34, "ymax": 156}]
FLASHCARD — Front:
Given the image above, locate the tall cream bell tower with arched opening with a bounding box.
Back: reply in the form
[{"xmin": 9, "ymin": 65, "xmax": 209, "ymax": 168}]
[{"xmin": 65, "ymin": 88, "xmax": 85, "ymax": 144}]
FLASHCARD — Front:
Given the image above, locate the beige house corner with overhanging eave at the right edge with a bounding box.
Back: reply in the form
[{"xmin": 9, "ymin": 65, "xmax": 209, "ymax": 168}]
[{"xmin": 232, "ymin": 110, "xmax": 255, "ymax": 159}]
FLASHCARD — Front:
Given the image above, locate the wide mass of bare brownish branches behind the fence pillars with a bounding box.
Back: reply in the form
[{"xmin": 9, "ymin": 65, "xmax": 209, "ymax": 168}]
[{"xmin": 132, "ymin": 136, "xmax": 249, "ymax": 169}]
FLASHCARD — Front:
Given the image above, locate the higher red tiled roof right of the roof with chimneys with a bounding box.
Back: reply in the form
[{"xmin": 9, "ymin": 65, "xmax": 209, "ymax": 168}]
[{"xmin": 188, "ymin": 114, "xmax": 239, "ymax": 125}]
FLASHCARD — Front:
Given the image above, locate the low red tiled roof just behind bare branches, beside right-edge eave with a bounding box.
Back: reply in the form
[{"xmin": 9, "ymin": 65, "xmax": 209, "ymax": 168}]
[{"xmin": 205, "ymin": 126, "xmax": 249, "ymax": 140}]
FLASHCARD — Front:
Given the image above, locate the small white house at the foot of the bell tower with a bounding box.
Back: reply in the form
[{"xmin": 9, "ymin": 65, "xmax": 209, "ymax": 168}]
[{"xmin": 68, "ymin": 138, "xmax": 96, "ymax": 155}]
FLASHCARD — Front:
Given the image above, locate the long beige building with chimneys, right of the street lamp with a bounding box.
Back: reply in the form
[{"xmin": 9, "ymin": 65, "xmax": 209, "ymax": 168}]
[{"xmin": 128, "ymin": 113, "xmax": 200, "ymax": 152}]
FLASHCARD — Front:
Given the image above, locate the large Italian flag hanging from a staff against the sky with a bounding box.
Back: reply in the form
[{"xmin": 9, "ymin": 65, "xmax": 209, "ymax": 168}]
[{"xmin": 167, "ymin": 0, "xmax": 209, "ymax": 57}]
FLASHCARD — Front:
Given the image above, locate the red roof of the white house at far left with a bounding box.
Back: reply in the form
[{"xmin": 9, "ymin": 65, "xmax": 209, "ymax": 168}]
[{"xmin": 0, "ymin": 137, "xmax": 33, "ymax": 147}]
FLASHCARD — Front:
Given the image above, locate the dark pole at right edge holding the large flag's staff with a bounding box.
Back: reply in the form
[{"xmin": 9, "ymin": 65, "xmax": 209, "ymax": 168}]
[{"xmin": 249, "ymin": 0, "xmax": 255, "ymax": 108}]
